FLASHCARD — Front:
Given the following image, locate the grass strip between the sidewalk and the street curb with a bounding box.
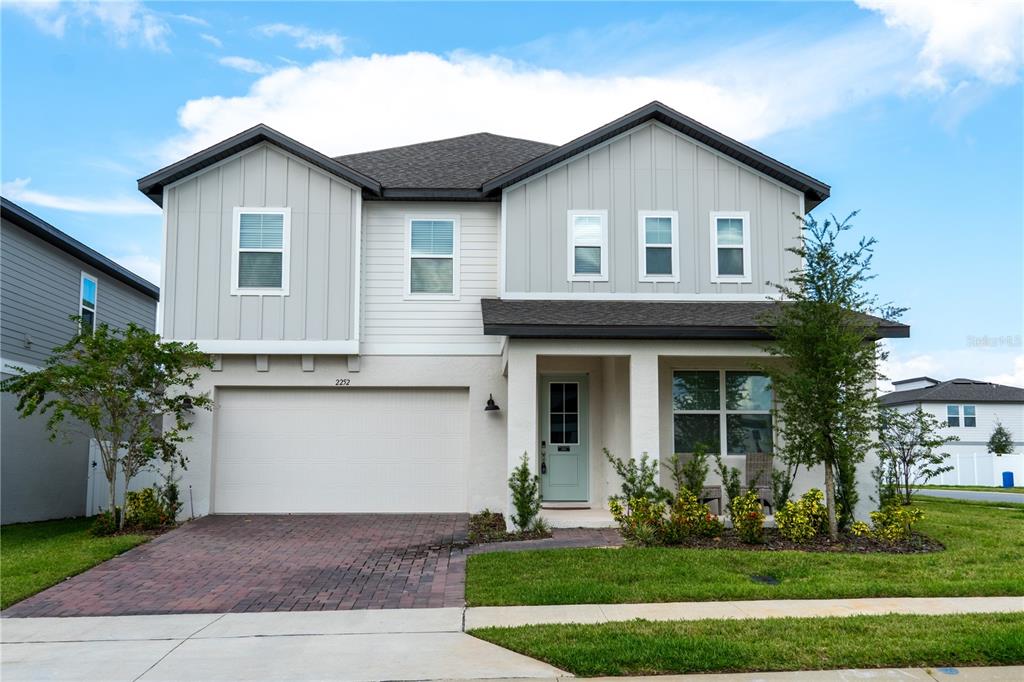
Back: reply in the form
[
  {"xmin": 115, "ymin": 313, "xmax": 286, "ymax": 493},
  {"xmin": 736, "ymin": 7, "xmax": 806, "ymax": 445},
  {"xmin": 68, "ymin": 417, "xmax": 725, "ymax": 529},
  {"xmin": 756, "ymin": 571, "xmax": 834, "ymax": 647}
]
[{"xmin": 470, "ymin": 613, "xmax": 1024, "ymax": 676}]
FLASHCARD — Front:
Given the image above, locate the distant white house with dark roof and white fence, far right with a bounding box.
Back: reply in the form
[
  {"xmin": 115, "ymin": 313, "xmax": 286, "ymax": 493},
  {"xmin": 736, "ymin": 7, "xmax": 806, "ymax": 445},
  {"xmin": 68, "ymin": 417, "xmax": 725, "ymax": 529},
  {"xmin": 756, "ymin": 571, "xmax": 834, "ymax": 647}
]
[{"xmin": 880, "ymin": 377, "xmax": 1024, "ymax": 485}]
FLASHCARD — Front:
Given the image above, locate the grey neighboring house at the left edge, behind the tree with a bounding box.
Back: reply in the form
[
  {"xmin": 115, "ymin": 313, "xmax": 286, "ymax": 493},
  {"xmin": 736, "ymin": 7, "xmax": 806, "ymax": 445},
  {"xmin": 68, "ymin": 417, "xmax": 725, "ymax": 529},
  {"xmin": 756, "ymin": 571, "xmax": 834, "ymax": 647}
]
[{"xmin": 0, "ymin": 199, "xmax": 159, "ymax": 523}]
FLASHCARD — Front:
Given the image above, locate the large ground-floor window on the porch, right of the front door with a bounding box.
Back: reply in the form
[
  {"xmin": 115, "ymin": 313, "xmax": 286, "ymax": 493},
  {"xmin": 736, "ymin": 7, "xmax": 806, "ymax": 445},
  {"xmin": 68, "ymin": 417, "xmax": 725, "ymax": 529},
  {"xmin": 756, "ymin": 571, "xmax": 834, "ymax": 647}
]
[{"xmin": 672, "ymin": 370, "xmax": 772, "ymax": 455}]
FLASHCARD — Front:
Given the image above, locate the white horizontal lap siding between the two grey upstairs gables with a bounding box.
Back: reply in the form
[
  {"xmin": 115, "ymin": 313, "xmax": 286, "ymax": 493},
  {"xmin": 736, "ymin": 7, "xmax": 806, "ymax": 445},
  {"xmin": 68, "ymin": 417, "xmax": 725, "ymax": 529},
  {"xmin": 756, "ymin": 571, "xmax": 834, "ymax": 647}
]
[{"xmin": 360, "ymin": 202, "xmax": 500, "ymax": 355}]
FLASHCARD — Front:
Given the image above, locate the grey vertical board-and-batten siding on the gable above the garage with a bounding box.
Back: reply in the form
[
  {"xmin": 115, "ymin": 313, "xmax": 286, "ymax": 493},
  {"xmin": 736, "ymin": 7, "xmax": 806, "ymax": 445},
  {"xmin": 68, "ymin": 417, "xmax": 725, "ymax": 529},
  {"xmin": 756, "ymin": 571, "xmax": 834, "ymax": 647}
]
[{"xmin": 163, "ymin": 144, "xmax": 362, "ymax": 341}]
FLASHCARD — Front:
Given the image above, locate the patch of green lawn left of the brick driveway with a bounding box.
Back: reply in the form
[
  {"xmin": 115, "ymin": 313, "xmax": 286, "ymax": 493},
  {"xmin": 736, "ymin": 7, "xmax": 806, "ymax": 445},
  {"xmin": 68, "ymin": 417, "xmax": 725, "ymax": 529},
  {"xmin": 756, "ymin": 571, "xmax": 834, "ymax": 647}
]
[{"xmin": 0, "ymin": 518, "xmax": 150, "ymax": 608}]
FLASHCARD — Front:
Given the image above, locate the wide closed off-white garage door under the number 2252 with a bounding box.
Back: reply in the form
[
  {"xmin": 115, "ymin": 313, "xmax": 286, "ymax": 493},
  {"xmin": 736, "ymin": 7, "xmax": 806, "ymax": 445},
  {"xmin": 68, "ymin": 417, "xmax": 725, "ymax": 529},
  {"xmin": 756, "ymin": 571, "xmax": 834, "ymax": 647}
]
[{"xmin": 213, "ymin": 388, "xmax": 469, "ymax": 514}]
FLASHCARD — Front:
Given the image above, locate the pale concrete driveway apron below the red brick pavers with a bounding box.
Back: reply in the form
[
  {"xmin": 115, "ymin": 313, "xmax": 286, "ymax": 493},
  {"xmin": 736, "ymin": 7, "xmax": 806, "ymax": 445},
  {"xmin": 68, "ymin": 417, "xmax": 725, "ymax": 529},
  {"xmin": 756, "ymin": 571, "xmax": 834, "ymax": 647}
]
[{"xmin": 0, "ymin": 608, "xmax": 566, "ymax": 682}]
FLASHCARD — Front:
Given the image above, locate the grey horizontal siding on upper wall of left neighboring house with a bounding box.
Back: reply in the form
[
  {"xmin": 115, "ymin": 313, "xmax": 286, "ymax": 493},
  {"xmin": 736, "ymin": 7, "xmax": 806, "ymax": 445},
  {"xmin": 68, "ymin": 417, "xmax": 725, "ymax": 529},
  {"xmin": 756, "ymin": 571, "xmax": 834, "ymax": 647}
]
[{"xmin": 0, "ymin": 220, "xmax": 157, "ymax": 366}]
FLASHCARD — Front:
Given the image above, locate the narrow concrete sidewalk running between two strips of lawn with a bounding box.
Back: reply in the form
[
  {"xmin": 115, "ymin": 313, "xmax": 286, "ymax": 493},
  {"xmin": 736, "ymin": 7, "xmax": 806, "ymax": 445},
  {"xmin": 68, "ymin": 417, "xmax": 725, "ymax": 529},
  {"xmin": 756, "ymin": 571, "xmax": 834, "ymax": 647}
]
[{"xmin": 465, "ymin": 597, "xmax": 1024, "ymax": 630}]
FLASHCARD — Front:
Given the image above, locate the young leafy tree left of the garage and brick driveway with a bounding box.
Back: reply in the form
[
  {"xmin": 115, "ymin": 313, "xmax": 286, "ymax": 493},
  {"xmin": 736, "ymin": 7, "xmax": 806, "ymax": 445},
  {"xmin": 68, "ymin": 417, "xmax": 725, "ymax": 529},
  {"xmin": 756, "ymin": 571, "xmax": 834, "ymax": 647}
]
[{"xmin": 0, "ymin": 324, "xmax": 213, "ymax": 526}]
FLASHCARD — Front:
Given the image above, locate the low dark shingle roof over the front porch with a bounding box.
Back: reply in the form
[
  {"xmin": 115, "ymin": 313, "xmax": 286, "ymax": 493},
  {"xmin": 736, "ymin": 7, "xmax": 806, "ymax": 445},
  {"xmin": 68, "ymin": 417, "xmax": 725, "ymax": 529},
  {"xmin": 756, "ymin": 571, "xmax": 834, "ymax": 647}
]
[{"xmin": 480, "ymin": 298, "xmax": 910, "ymax": 339}]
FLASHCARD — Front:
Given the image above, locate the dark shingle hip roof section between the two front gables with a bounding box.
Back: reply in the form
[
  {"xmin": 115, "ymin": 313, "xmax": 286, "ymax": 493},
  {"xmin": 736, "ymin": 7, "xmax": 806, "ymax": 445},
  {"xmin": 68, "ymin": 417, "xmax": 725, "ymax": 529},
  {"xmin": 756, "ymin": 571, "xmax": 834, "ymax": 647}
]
[{"xmin": 335, "ymin": 133, "xmax": 555, "ymax": 194}]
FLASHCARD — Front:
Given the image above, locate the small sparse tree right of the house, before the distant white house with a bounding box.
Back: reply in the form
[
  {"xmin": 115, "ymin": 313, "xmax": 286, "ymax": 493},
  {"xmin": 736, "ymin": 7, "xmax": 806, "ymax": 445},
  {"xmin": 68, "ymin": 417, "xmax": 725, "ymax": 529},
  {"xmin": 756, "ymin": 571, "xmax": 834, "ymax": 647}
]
[{"xmin": 879, "ymin": 408, "xmax": 959, "ymax": 505}]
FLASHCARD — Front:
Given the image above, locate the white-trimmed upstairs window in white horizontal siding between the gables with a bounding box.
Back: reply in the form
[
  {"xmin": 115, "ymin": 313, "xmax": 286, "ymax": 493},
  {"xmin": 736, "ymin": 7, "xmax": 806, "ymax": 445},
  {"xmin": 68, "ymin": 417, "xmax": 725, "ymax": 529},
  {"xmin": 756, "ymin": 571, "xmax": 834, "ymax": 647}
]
[{"xmin": 406, "ymin": 216, "xmax": 459, "ymax": 299}]
